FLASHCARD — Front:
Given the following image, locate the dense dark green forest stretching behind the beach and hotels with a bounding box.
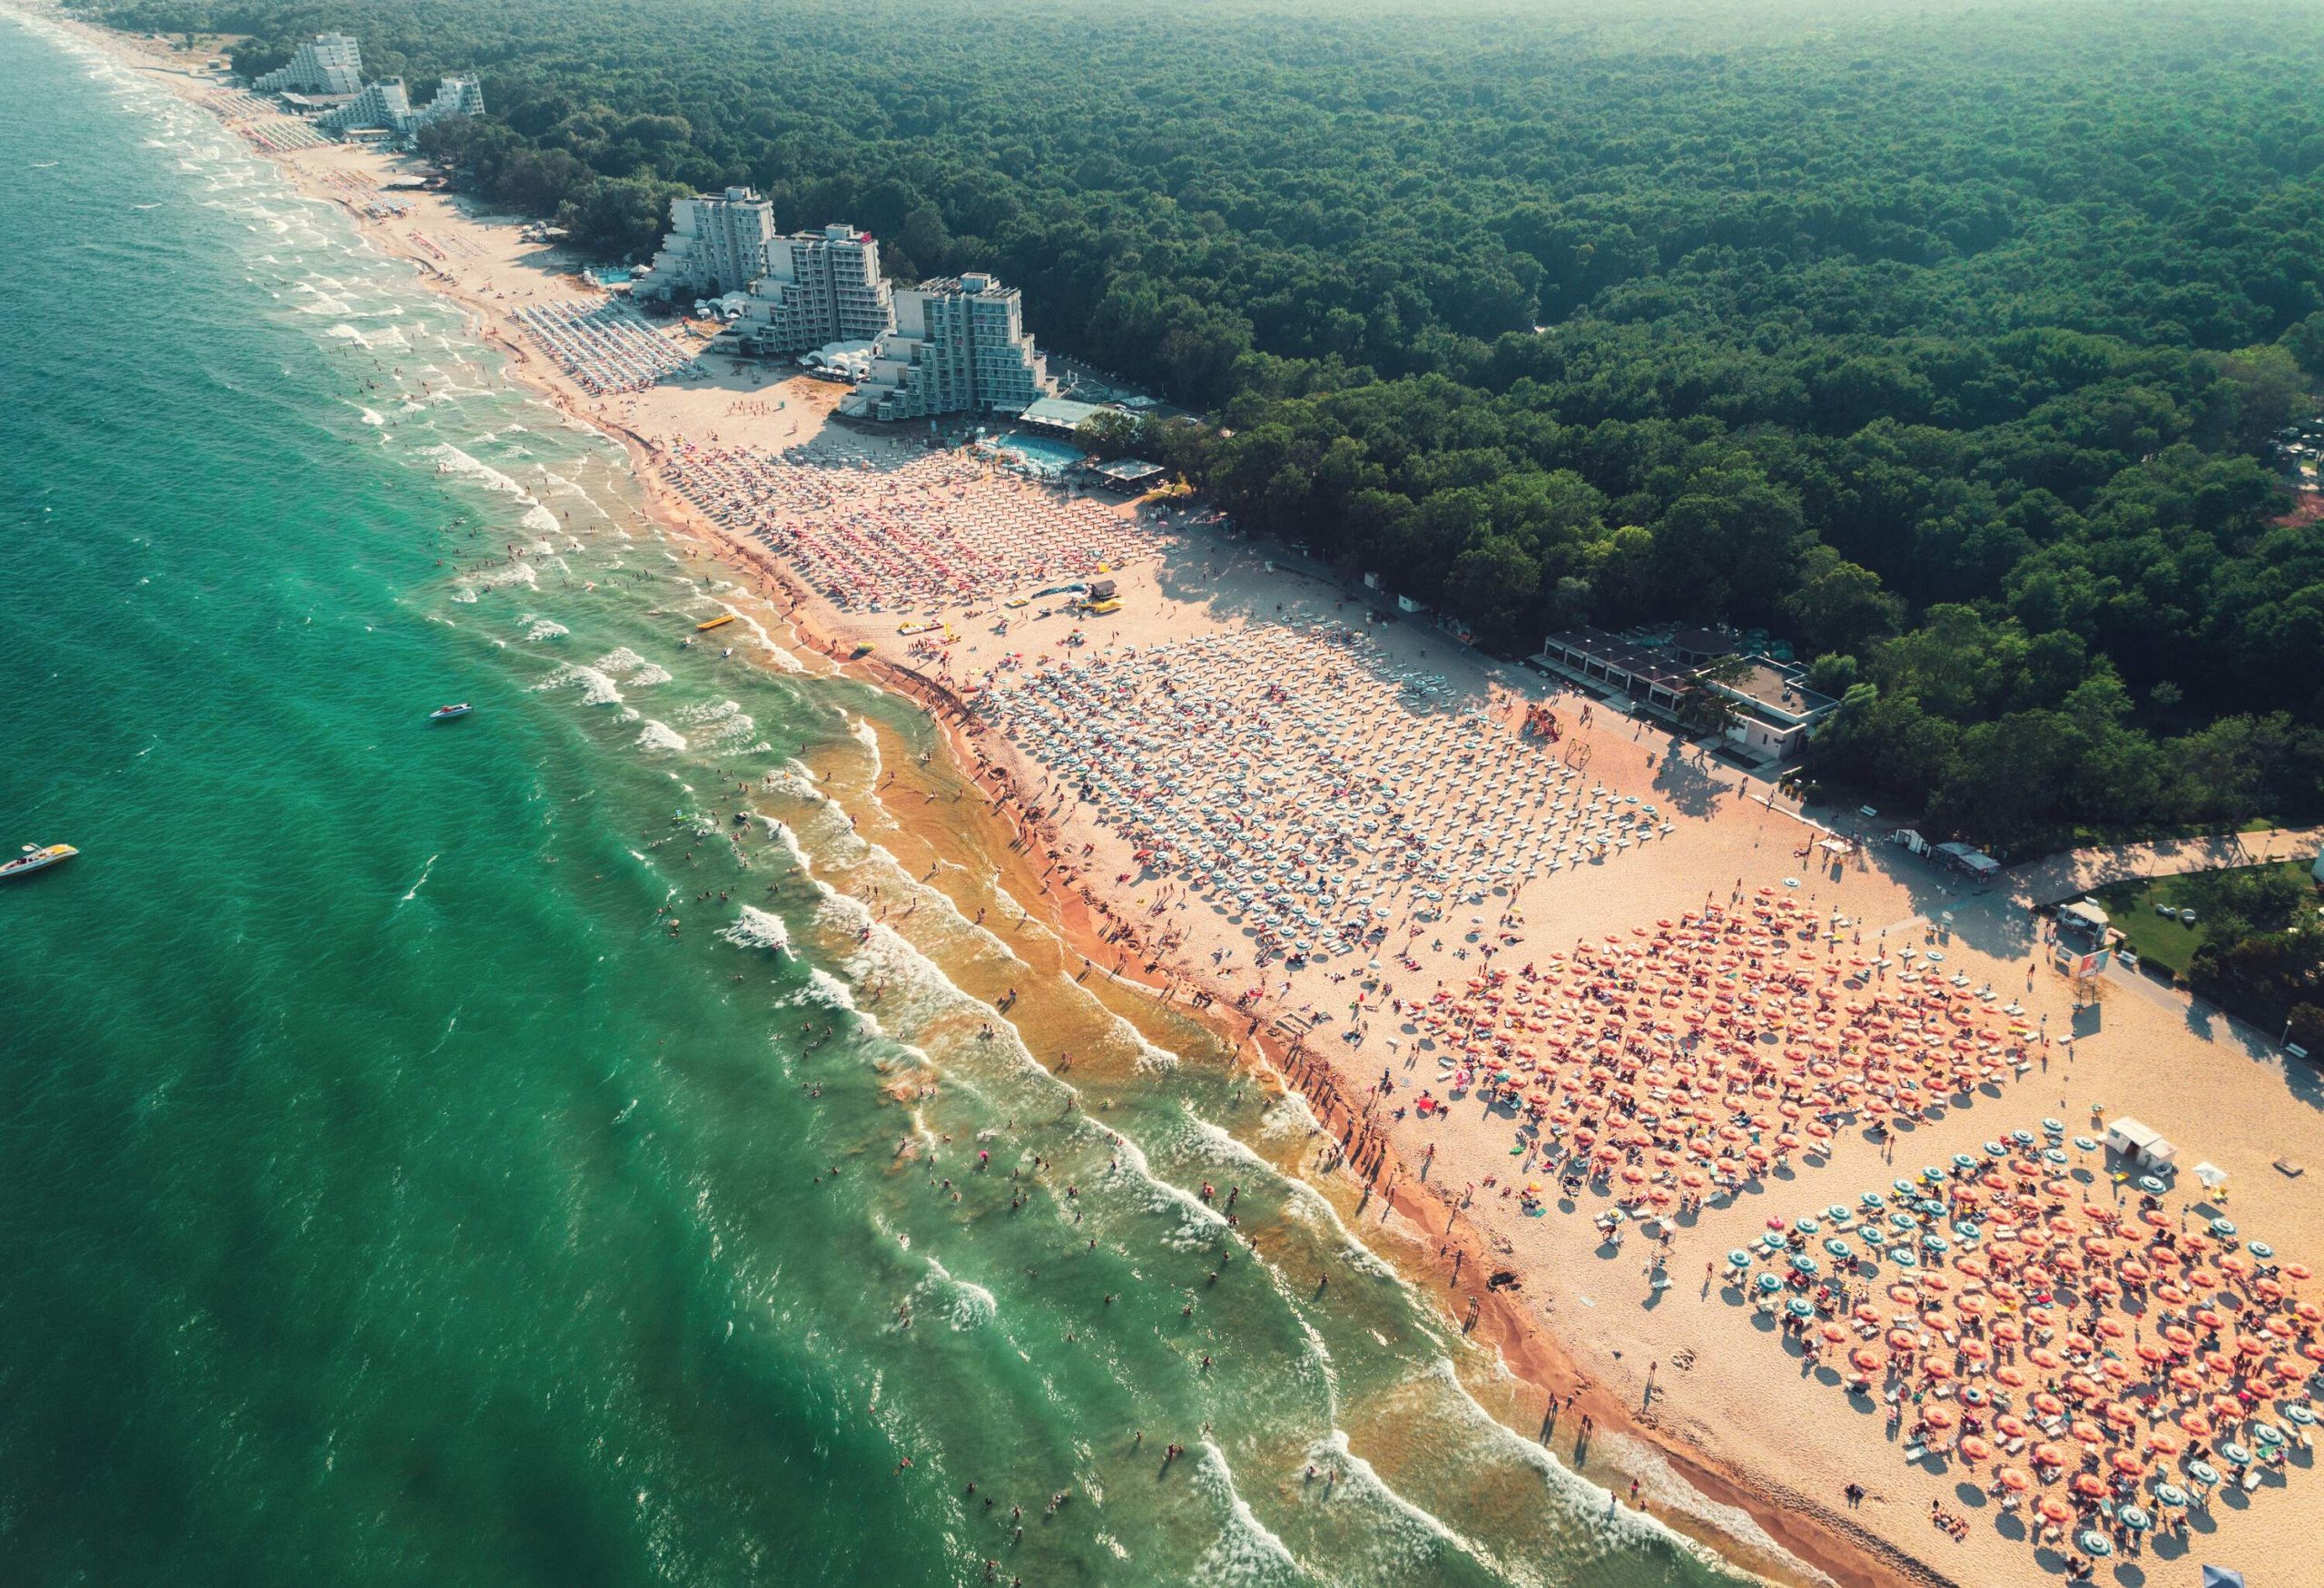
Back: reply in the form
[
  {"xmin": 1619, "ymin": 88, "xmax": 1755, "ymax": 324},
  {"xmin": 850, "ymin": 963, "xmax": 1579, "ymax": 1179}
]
[{"xmin": 82, "ymin": 0, "xmax": 2324, "ymax": 849}]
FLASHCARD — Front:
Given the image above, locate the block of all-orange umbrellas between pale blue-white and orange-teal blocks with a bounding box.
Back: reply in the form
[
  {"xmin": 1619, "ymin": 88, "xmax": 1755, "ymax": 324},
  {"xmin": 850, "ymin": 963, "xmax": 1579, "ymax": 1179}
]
[{"xmin": 1392, "ymin": 886, "xmax": 2045, "ymax": 1228}]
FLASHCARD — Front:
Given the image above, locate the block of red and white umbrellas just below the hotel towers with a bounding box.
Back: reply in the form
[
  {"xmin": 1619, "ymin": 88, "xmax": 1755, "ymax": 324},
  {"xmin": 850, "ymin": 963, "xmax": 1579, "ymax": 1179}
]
[{"xmin": 663, "ymin": 432, "xmax": 1157, "ymax": 611}]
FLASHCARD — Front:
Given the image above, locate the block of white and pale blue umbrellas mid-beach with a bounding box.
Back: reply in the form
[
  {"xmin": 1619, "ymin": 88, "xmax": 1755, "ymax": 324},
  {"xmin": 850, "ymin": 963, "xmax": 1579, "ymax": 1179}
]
[{"xmin": 983, "ymin": 618, "xmax": 1671, "ymax": 972}]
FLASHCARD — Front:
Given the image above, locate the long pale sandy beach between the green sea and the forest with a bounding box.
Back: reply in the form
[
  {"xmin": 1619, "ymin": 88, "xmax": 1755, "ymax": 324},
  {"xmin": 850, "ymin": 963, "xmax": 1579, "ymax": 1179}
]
[{"xmin": 58, "ymin": 18, "xmax": 2324, "ymax": 1588}]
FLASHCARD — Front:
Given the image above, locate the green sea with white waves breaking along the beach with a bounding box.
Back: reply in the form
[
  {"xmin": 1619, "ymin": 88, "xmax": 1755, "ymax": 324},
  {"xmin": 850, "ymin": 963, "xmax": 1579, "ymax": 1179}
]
[{"xmin": 0, "ymin": 9, "xmax": 1740, "ymax": 1588}]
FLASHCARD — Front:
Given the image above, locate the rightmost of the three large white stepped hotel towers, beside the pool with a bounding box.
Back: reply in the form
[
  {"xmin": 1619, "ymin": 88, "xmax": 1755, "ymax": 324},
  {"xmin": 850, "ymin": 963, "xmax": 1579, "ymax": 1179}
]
[{"xmin": 843, "ymin": 274, "xmax": 1050, "ymax": 419}]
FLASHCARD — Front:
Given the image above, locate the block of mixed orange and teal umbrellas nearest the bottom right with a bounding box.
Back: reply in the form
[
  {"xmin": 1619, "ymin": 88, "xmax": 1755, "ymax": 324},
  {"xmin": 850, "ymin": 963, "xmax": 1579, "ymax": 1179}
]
[{"xmin": 1729, "ymin": 1119, "xmax": 2324, "ymax": 1576}]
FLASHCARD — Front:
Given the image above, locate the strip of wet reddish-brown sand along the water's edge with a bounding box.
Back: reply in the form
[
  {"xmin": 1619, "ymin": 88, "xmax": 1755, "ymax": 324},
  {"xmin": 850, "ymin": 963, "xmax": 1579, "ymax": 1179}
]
[{"xmin": 14, "ymin": 12, "xmax": 1952, "ymax": 1588}]
